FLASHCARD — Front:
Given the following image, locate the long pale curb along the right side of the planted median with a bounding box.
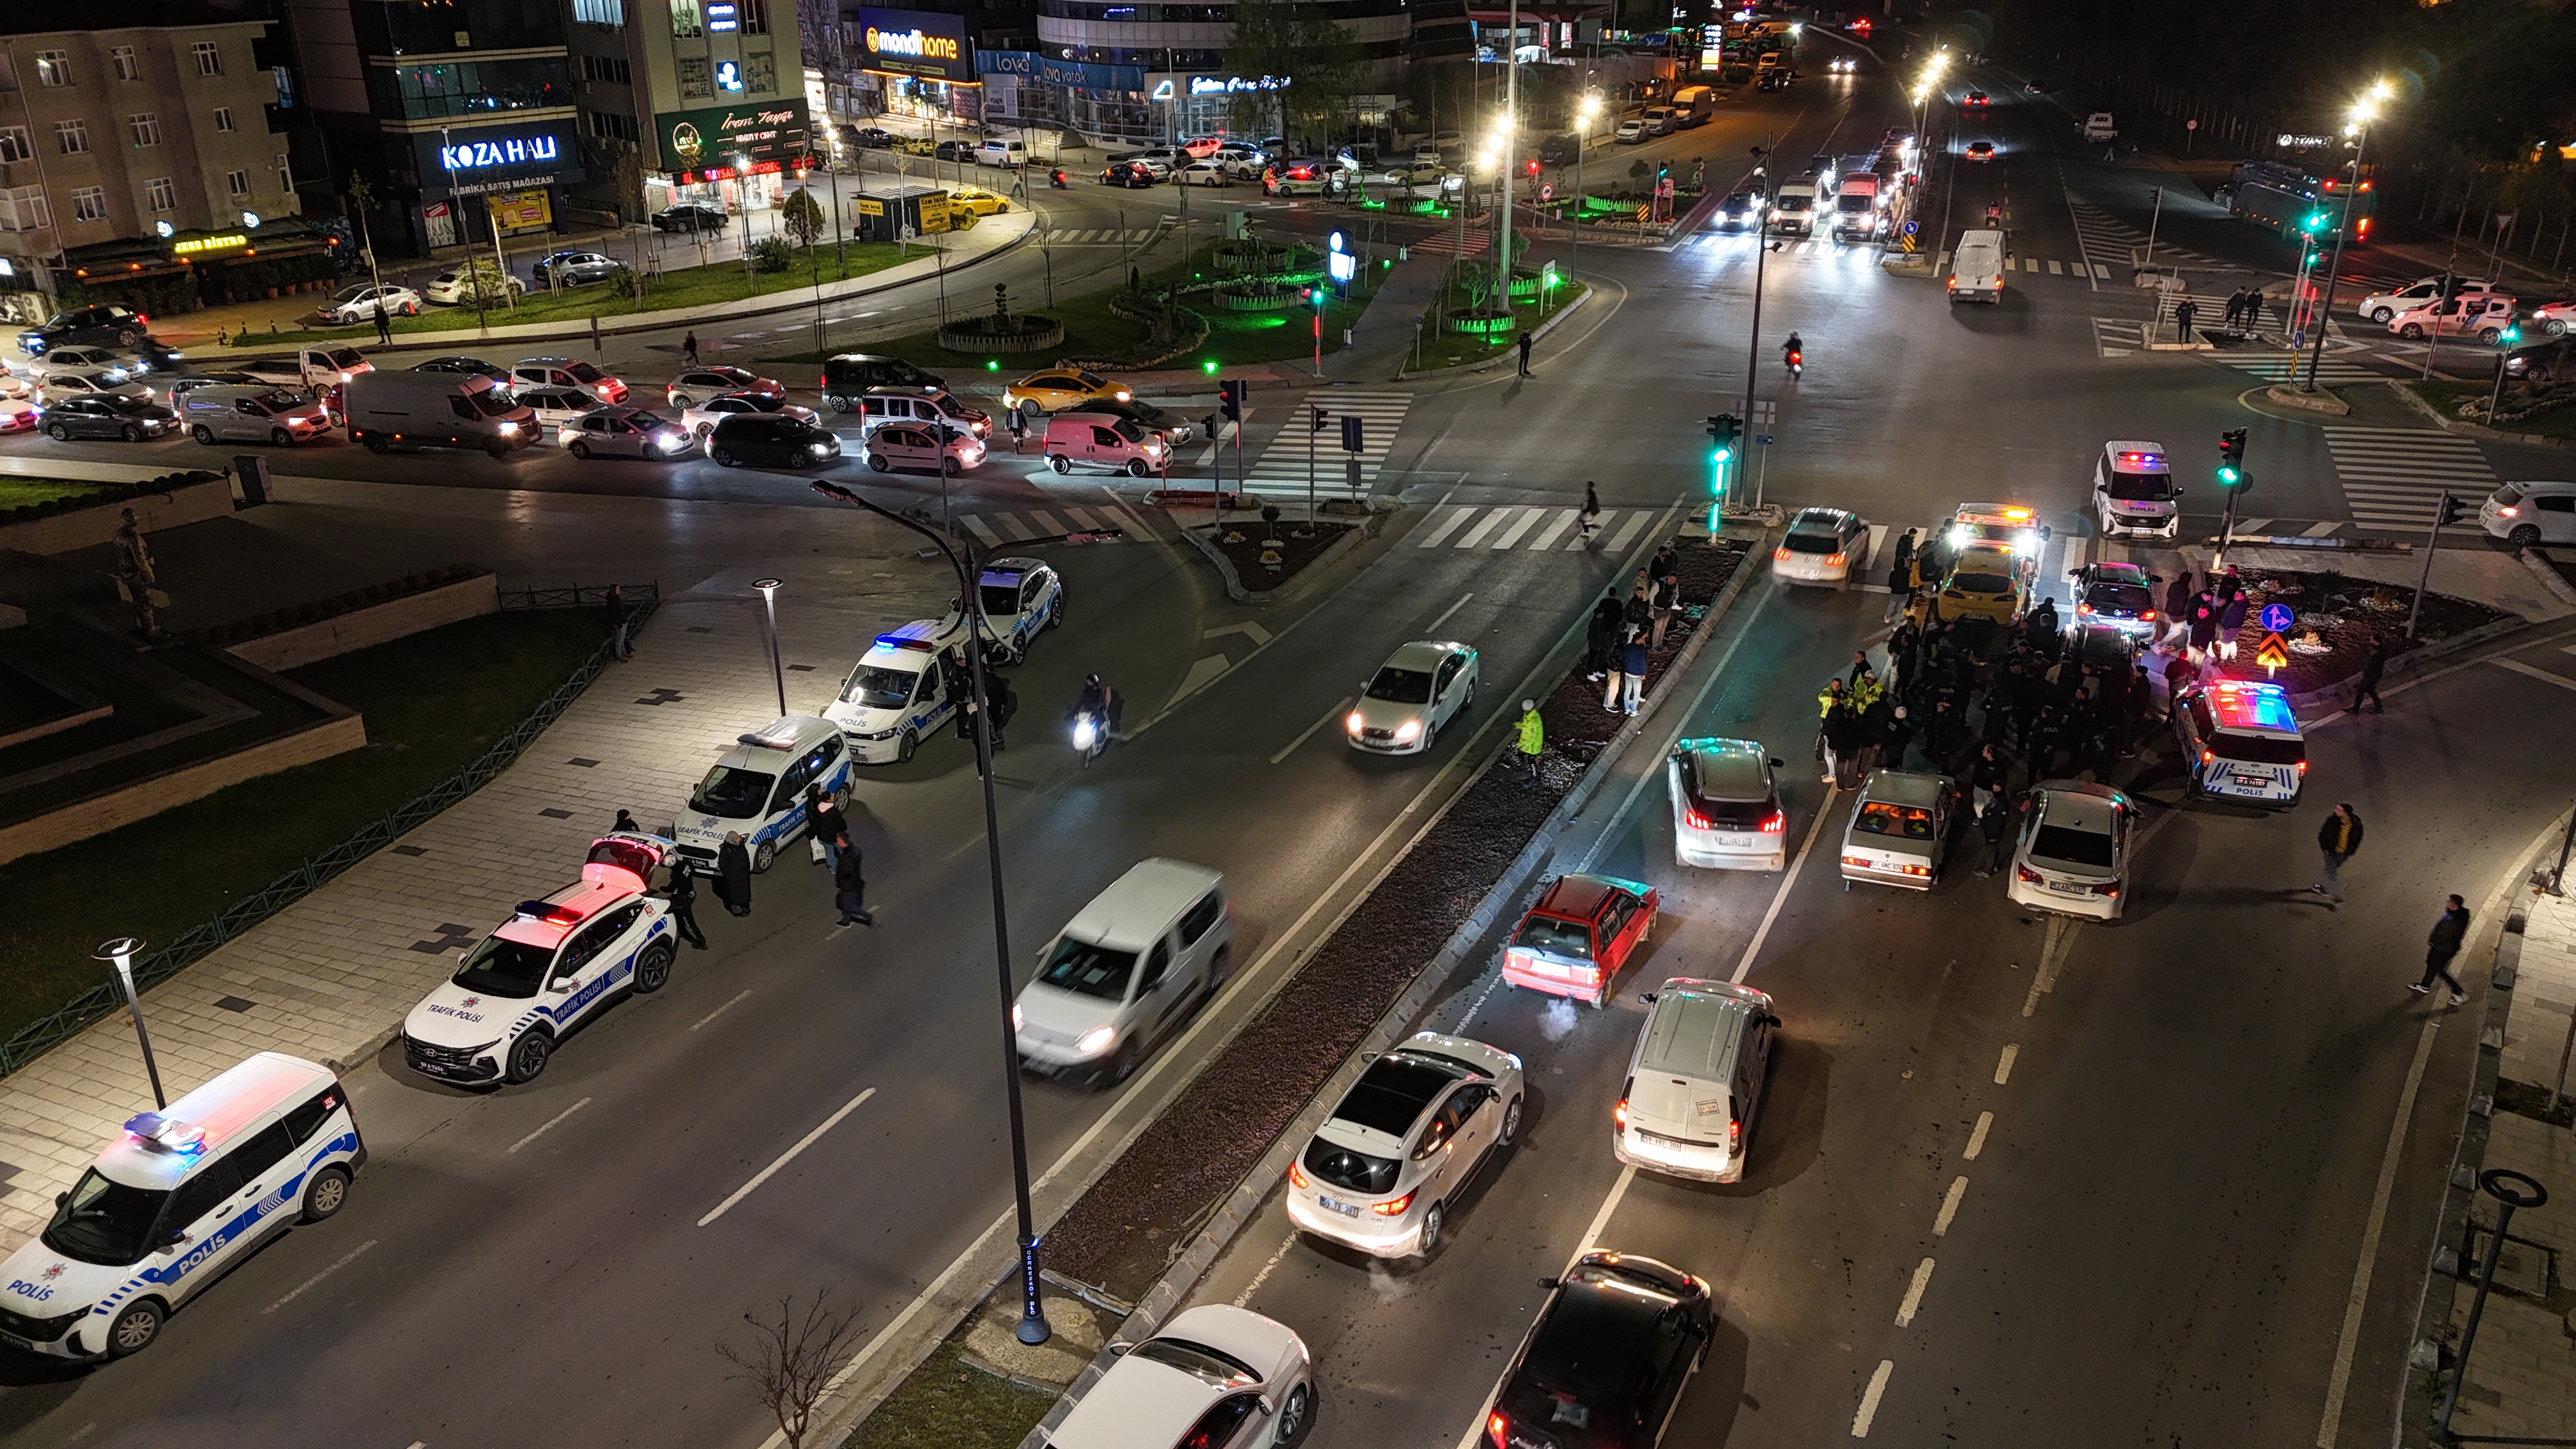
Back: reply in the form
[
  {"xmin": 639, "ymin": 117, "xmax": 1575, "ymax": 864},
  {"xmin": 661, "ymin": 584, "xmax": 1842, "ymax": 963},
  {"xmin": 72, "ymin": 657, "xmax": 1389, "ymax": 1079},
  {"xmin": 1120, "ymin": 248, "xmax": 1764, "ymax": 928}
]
[{"xmin": 1020, "ymin": 523, "xmax": 1759, "ymax": 1449}]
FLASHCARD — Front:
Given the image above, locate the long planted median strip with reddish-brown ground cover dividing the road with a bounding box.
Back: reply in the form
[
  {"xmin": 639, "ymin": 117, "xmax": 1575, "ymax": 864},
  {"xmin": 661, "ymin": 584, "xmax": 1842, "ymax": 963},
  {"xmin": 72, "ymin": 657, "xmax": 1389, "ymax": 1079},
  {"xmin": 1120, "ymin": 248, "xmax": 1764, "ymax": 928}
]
[{"xmin": 848, "ymin": 518, "xmax": 1754, "ymax": 1449}]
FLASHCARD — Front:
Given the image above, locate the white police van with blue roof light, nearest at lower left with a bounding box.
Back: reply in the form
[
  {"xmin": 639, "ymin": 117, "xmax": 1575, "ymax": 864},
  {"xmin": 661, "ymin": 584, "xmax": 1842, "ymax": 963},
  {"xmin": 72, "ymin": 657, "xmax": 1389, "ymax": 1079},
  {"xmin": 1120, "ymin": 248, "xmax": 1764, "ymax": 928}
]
[{"xmin": 0, "ymin": 1052, "xmax": 366, "ymax": 1359}]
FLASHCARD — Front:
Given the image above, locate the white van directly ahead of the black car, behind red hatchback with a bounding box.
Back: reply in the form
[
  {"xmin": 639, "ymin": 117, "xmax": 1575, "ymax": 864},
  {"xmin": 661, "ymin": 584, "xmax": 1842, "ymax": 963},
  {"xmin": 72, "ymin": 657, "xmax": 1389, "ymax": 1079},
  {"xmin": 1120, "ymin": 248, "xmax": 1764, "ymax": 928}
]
[{"xmin": 1610, "ymin": 977, "xmax": 1780, "ymax": 1183}]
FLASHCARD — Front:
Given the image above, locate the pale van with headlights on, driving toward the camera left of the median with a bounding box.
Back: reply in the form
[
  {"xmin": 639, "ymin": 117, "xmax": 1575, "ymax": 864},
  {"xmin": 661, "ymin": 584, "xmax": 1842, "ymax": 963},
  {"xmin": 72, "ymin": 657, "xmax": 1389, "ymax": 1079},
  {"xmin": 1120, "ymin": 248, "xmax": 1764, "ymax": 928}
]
[{"xmin": 1010, "ymin": 856, "xmax": 1234, "ymax": 1083}]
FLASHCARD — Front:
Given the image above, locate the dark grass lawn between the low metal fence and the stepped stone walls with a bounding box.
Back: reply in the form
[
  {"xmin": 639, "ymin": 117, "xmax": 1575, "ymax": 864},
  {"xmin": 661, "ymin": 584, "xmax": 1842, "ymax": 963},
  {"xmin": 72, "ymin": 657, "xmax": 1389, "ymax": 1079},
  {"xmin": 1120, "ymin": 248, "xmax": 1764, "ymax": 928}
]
[{"xmin": 0, "ymin": 608, "xmax": 606, "ymax": 1039}]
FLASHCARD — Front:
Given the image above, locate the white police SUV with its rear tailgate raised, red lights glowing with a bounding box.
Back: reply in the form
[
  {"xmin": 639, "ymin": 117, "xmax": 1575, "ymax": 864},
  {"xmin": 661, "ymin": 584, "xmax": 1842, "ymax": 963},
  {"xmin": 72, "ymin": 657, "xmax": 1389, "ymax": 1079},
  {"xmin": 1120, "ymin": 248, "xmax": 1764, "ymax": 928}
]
[{"xmin": 402, "ymin": 836, "xmax": 680, "ymax": 1085}]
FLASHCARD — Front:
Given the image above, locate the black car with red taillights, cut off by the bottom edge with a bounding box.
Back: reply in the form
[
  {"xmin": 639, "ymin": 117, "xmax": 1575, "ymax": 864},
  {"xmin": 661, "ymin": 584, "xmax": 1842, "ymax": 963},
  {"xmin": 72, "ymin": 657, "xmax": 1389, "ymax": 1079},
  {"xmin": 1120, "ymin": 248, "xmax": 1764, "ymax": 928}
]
[{"xmin": 1483, "ymin": 1253, "xmax": 1718, "ymax": 1449}]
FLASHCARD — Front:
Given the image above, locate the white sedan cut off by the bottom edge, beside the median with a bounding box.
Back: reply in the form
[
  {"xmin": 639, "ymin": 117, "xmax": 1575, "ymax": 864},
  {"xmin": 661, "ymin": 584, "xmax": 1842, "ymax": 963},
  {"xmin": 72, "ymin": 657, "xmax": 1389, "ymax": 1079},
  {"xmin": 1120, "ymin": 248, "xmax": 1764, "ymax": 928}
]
[{"xmin": 1046, "ymin": 1302, "xmax": 1314, "ymax": 1449}]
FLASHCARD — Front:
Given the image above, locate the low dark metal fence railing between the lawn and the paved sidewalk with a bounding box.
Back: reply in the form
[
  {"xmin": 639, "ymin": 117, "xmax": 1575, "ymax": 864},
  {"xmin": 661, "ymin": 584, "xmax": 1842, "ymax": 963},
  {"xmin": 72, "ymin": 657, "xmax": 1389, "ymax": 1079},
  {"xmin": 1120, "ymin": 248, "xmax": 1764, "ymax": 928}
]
[{"xmin": 0, "ymin": 583, "xmax": 662, "ymax": 1075}]
